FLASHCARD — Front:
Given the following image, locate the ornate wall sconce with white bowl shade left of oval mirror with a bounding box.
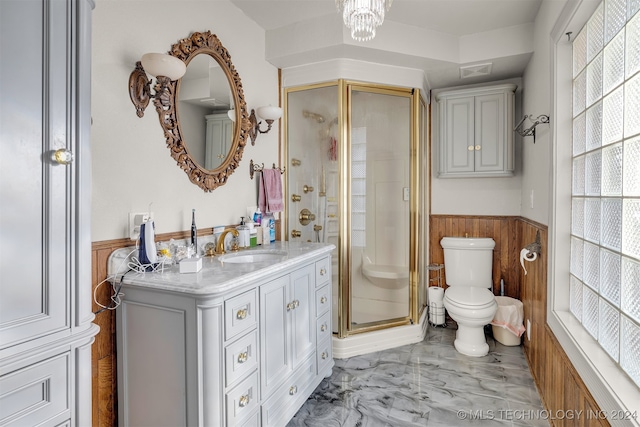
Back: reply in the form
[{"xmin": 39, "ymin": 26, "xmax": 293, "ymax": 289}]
[{"xmin": 129, "ymin": 53, "xmax": 187, "ymax": 117}]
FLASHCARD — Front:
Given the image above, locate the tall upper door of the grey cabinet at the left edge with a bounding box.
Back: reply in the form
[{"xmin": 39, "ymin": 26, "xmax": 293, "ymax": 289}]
[{"xmin": 0, "ymin": 1, "xmax": 72, "ymax": 353}]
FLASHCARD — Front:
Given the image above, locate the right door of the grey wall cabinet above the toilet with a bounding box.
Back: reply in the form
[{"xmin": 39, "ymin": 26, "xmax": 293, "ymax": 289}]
[{"xmin": 475, "ymin": 93, "xmax": 505, "ymax": 172}]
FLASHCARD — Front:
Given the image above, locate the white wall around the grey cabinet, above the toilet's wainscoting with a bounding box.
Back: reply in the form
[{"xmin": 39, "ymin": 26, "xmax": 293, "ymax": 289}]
[{"xmin": 431, "ymin": 77, "xmax": 524, "ymax": 216}]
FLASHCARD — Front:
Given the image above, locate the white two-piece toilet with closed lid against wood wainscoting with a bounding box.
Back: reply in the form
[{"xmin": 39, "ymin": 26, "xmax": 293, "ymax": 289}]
[{"xmin": 440, "ymin": 237, "xmax": 498, "ymax": 357}]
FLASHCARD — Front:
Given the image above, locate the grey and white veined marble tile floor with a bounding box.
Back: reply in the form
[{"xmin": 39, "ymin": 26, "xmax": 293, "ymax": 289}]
[{"xmin": 287, "ymin": 321, "xmax": 549, "ymax": 427}]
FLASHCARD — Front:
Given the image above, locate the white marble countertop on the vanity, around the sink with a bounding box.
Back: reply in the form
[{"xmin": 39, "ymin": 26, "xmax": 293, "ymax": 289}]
[{"xmin": 109, "ymin": 242, "xmax": 335, "ymax": 297}]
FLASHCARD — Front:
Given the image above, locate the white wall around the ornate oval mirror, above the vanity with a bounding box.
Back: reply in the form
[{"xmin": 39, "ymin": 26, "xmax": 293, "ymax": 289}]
[{"xmin": 91, "ymin": 0, "xmax": 278, "ymax": 241}]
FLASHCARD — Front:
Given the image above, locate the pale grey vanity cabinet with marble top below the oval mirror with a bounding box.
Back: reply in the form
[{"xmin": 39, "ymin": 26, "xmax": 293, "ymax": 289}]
[{"xmin": 116, "ymin": 243, "xmax": 333, "ymax": 427}]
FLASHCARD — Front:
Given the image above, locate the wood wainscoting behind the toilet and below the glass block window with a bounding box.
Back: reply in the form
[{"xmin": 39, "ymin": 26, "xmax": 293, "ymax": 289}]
[{"xmin": 429, "ymin": 215, "xmax": 609, "ymax": 427}]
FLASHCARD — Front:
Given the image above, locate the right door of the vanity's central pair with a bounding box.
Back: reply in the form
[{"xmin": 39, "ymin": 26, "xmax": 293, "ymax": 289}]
[{"xmin": 289, "ymin": 265, "xmax": 316, "ymax": 369}]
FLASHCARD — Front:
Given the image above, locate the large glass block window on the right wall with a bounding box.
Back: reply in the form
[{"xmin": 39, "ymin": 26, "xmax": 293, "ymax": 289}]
[{"xmin": 569, "ymin": 0, "xmax": 640, "ymax": 386}]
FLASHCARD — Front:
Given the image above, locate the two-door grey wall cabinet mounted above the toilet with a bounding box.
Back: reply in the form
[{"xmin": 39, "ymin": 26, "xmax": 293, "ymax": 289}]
[{"xmin": 436, "ymin": 84, "xmax": 516, "ymax": 178}]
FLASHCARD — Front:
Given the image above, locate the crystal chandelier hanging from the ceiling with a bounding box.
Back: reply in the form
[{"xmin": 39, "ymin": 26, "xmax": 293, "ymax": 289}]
[{"xmin": 336, "ymin": 0, "xmax": 393, "ymax": 42}]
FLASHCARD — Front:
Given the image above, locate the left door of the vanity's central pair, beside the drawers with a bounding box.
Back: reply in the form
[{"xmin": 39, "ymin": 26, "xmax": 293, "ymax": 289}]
[{"xmin": 260, "ymin": 276, "xmax": 293, "ymax": 397}]
